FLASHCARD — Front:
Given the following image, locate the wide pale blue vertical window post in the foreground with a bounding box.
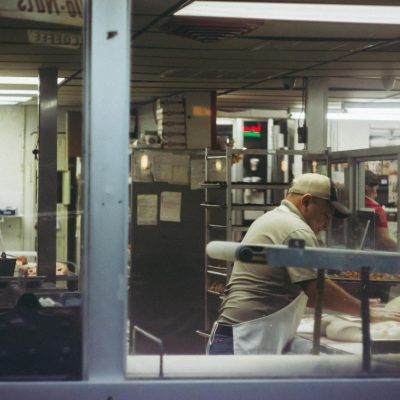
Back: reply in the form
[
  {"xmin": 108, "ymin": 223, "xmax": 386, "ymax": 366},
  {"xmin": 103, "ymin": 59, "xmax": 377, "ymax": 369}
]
[{"xmin": 82, "ymin": 0, "xmax": 131, "ymax": 382}]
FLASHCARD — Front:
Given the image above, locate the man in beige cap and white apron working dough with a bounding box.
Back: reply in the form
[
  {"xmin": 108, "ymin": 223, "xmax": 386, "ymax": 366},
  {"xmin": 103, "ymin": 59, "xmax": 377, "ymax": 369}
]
[{"xmin": 207, "ymin": 173, "xmax": 374, "ymax": 354}]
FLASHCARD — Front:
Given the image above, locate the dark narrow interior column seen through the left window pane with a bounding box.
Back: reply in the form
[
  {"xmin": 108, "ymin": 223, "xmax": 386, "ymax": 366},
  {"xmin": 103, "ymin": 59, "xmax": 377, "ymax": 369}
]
[{"xmin": 37, "ymin": 69, "xmax": 57, "ymax": 282}]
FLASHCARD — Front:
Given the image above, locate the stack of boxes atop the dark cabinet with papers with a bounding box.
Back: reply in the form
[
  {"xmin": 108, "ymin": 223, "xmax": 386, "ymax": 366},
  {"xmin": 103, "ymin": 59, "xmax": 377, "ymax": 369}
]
[{"xmin": 156, "ymin": 96, "xmax": 186, "ymax": 149}]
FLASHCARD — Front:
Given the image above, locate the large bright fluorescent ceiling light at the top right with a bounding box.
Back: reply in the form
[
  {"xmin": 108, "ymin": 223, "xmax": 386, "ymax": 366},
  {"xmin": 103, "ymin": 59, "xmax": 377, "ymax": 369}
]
[{"xmin": 174, "ymin": 1, "xmax": 400, "ymax": 25}]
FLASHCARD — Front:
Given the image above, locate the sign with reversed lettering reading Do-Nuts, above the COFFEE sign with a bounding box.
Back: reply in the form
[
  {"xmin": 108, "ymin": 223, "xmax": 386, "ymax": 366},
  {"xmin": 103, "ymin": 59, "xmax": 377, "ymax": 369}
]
[{"xmin": 0, "ymin": 0, "xmax": 83, "ymax": 26}]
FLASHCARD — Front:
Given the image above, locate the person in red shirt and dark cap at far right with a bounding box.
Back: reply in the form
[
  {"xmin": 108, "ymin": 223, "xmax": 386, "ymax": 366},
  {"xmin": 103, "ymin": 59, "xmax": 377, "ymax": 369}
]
[{"xmin": 365, "ymin": 170, "xmax": 397, "ymax": 251}]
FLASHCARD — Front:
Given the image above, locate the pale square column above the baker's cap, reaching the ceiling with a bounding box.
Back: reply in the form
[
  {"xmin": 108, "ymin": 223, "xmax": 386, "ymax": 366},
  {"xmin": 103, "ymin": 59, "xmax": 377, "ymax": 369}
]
[{"xmin": 306, "ymin": 78, "xmax": 328, "ymax": 153}]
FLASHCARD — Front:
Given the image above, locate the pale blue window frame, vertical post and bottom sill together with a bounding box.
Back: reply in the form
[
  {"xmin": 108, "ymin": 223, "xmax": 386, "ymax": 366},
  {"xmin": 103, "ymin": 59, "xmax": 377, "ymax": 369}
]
[{"xmin": 0, "ymin": 0, "xmax": 400, "ymax": 400}]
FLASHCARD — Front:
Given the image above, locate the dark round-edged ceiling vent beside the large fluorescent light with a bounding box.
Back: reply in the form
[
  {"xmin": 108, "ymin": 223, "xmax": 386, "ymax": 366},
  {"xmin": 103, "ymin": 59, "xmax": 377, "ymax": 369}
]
[{"xmin": 160, "ymin": 17, "xmax": 264, "ymax": 43}]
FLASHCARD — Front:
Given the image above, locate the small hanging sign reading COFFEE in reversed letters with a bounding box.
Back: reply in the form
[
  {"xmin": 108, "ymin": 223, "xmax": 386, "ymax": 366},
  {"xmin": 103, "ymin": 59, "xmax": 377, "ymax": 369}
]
[{"xmin": 27, "ymin": 29, "xmax": 82, "ymax": 49}]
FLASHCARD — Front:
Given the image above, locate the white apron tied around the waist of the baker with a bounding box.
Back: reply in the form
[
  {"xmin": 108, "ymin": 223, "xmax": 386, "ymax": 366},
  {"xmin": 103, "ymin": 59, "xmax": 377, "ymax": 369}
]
[{"xmin": 233, "ymin": 292, "xmax": 308, "ymax": 354}]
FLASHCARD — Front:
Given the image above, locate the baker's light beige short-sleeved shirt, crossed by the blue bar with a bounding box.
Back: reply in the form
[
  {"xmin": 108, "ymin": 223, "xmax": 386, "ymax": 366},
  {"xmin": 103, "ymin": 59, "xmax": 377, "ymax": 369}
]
[{"xmin": 219, "ymin": 200, "xmax": 318, "ymax": 324}]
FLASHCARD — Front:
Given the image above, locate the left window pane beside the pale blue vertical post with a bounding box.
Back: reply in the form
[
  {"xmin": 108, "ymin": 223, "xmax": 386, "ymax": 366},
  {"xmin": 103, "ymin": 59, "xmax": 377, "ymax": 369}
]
[{"xmin": 0, "ymin": 9, "xmax": 83, "ymax": 380}]
